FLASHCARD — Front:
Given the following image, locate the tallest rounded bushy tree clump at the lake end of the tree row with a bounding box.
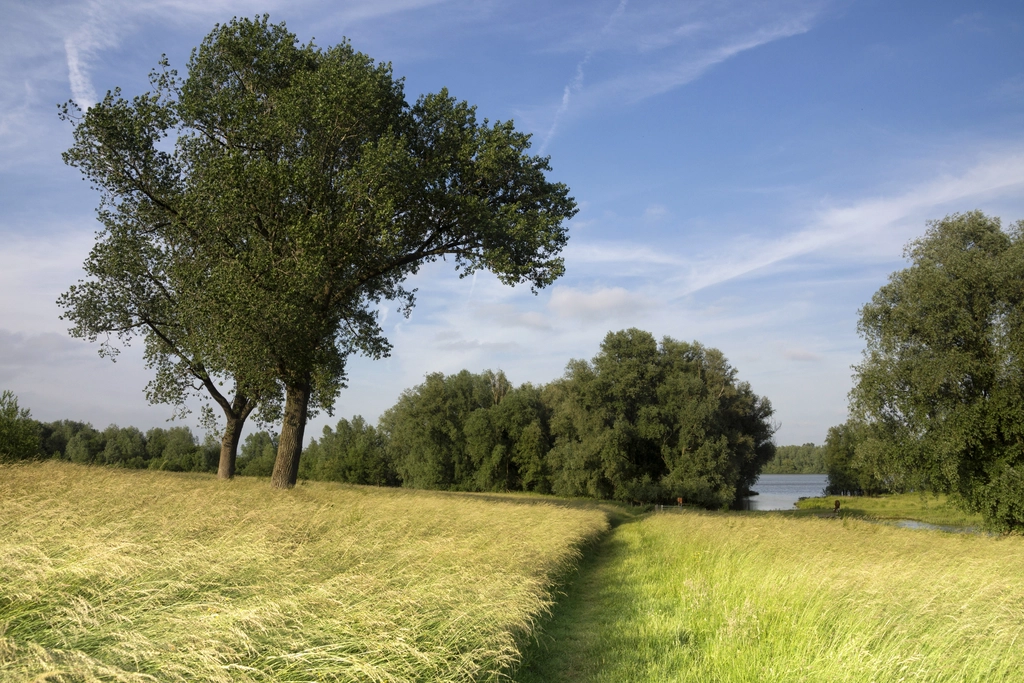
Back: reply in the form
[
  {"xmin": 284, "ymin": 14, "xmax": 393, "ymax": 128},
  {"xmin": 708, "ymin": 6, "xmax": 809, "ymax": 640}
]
[{"xmin": 545, "ymin": 329, "xmax": 774, "ymax": 508}]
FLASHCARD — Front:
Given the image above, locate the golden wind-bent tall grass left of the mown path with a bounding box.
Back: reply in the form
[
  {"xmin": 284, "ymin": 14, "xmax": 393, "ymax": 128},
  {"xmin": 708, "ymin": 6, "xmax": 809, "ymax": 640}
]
[{"xmin": 0, "ymin": 462, "xmax": 607, "ymax": 682}]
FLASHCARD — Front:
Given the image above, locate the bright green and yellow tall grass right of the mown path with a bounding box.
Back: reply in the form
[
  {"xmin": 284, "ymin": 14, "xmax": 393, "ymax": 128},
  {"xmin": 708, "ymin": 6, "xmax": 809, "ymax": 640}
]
[{"xmin": 516, "ymin": 512, "xmax": 1024, "ymax": 683}]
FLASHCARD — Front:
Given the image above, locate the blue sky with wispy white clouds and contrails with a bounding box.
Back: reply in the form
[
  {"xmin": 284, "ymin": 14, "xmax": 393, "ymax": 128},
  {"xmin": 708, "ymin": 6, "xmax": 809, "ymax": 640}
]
[{"xmin": 0, "ymin": 0, "xmax": 1024, "ymax": 444}]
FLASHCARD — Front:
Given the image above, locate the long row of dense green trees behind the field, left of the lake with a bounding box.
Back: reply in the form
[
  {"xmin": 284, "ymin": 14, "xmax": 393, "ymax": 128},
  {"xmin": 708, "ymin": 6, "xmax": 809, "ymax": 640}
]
[{"xmin": 4, "ymin": 329, "xmax": 775, "ymax": 509}]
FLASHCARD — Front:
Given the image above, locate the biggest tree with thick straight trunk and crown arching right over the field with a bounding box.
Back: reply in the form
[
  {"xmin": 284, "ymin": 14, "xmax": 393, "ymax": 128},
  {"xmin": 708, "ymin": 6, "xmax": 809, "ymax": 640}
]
[{"xmin": 59, "ymin": 16, "xmax": 575, "ymax": 487}]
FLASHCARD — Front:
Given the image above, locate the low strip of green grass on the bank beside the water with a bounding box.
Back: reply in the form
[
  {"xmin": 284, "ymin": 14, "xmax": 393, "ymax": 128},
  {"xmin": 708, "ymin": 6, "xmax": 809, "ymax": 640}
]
[{"xmin": 797, "ymin": 494, "xmax": 983, "ymax": 527}]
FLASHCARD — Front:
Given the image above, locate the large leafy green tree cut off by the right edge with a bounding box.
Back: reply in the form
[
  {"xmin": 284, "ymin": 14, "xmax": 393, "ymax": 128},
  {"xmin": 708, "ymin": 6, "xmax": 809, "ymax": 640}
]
[{"xmin": 851, "ymin": 211, "xmax": 1024, "ymax": 528}]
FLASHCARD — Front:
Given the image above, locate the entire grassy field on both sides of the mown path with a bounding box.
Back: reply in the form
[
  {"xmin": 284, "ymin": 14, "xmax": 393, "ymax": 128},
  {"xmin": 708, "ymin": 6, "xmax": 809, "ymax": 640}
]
[{"xmin": 0, "ymin": 462, "xmax": 1024, "ymax": 683}]
